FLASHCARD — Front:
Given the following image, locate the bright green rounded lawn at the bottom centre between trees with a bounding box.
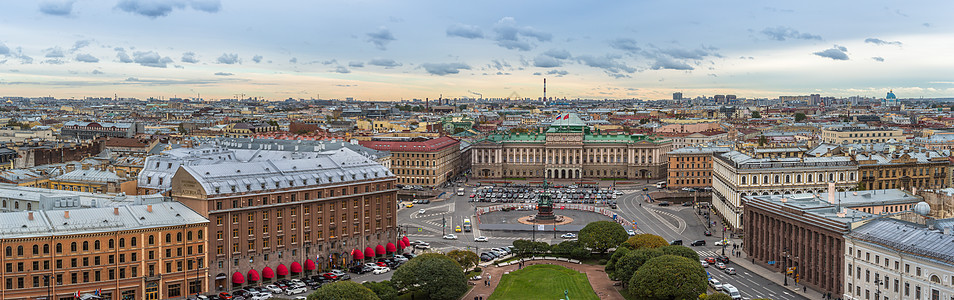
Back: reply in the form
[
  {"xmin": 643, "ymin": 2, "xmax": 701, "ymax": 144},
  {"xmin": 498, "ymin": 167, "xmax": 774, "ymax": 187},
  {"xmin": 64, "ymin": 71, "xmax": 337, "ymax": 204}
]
[{"xmin": 488, "ymin": 265, "xmax": 599, "ymax": 300}]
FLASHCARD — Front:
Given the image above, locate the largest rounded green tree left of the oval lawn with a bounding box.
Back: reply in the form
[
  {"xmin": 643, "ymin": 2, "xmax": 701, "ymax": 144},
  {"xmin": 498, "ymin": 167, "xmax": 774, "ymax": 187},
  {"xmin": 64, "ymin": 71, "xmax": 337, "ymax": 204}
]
[{"xmin": 391, "ymin": 253, "xmax": 467, "ymax": 300}]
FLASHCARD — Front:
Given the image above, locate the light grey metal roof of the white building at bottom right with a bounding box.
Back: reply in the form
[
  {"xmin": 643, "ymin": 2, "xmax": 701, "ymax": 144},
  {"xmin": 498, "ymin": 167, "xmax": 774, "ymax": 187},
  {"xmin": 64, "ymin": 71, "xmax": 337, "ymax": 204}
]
[{"xmin": 849, "ymin": 218, "xmax": 954, "ymax": 265}]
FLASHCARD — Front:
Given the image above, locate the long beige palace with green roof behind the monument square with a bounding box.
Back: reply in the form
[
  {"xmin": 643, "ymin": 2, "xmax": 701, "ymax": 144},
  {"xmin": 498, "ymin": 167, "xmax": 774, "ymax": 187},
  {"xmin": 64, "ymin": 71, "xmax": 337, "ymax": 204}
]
[{"xmin": 472, "ymin": 113, "xmax": 672, "ymax": 179}]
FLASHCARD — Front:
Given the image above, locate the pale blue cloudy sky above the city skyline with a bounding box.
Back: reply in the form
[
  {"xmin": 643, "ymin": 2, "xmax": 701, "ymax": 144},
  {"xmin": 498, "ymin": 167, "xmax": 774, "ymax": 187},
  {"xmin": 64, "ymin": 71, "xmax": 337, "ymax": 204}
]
[{"xmin": 0, "ymin": 0, "xmax": 954, "ymax": 100}]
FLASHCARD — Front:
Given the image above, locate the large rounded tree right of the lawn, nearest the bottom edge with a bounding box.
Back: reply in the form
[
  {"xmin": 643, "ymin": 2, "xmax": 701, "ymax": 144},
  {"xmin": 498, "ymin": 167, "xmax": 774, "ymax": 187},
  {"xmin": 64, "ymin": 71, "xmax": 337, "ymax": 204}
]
[{"xmin": 629, "ymin": 255, "xmax": 707, "ymax": 300}]
